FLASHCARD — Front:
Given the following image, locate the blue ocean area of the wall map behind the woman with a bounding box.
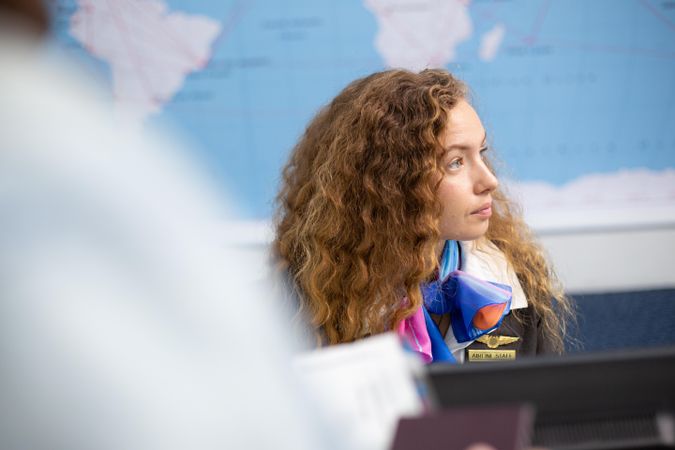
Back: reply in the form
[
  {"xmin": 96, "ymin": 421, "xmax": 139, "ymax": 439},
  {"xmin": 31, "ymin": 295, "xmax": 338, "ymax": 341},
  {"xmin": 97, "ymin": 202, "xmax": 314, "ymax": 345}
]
[{"xmin": 48, "ymin": 0, "xmax": 675, "ymax": 219}]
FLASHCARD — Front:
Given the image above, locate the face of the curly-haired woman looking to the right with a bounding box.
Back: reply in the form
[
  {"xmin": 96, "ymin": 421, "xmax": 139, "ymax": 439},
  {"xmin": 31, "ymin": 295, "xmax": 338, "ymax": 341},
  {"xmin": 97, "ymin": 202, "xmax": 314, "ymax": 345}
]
[{"xmin": 438, "ymin": 100, "xmax": 498, "ymax": 241}]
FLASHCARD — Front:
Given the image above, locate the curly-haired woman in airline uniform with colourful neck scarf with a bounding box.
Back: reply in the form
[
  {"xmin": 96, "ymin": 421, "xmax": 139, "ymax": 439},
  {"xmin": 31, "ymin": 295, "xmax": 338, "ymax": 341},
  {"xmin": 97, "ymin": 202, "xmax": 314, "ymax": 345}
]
[{"xmin": 274, "ymin": 70, "xmax": 571, "ymax": 361}]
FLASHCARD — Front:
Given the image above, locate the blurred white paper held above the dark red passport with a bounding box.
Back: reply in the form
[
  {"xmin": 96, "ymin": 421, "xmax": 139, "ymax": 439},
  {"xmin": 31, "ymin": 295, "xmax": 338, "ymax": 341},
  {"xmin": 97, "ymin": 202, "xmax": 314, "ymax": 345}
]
[{"xmin": 293, "ymin": 333, "xmax": 423, "ymax": 449}]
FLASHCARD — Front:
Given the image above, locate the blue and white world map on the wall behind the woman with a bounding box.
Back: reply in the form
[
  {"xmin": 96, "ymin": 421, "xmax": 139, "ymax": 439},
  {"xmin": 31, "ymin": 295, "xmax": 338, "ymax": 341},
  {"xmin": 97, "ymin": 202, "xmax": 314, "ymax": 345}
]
[{"xmin": 54, "ymin": 0, "xmax": 675, "ymax": 229}]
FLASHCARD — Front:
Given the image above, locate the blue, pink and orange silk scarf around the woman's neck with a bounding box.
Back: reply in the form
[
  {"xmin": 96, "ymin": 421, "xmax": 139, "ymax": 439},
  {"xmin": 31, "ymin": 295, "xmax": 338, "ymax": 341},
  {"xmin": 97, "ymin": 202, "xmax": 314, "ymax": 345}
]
[{"xmin": 397, "ymin": 241, "xmax": 511, "ymax": 363}]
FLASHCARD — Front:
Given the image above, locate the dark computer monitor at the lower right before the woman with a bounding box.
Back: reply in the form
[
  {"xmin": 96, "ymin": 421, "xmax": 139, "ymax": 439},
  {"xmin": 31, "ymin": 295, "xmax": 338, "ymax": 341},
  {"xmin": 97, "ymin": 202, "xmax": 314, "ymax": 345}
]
[{"xmin": 428, "ymin": 347, "xmax": 675, "ymax": 450}]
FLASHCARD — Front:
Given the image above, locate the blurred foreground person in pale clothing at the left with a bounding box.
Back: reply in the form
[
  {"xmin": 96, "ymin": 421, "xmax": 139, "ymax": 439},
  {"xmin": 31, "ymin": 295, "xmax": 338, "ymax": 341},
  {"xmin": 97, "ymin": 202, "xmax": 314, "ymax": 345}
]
[{"xmin": 0, "ymin": 0, "xmax": 324, "ymax": 449}]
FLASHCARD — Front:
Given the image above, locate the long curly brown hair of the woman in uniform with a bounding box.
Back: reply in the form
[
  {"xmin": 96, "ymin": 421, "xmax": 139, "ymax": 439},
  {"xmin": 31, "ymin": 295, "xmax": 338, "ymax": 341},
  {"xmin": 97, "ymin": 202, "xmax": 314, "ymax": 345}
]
[{"xmin": 273, "ymin": 70, "xmax": 571, "ymax": 351}]
